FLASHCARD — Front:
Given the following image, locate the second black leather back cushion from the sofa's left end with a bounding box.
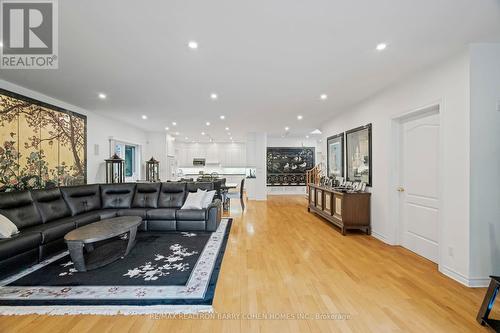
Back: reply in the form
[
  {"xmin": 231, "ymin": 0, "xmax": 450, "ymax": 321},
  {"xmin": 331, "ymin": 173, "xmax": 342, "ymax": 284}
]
[{"xmin": 31, "ymin": 188, "xmax": 71, "ymax": 223}]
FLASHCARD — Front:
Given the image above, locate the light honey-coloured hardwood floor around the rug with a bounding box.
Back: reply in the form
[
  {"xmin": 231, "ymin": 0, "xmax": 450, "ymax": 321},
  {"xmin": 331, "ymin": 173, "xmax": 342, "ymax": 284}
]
[{"xmin": 0, "ymin": 196, "xmax": 492, "ymax": 333}]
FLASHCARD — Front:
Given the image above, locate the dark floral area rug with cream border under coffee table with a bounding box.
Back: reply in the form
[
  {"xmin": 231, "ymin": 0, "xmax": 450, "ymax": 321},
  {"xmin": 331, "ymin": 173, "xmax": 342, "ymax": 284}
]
[{"xmin": 0, "ymin": 219, "xmax": 232, "ymax": 315}]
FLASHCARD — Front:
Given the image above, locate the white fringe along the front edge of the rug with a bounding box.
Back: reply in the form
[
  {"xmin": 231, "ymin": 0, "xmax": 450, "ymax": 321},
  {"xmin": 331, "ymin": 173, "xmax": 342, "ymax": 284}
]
[{"xmin": 0, "ymin": 305, "xmax": 214, "ymax": 316}]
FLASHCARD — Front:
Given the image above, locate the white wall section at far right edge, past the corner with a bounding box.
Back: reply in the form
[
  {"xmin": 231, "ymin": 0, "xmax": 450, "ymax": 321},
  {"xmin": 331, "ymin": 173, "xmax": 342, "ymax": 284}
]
[{"xmin": 470, "ymin": 44, "xmax": 500, "ymax": 281}]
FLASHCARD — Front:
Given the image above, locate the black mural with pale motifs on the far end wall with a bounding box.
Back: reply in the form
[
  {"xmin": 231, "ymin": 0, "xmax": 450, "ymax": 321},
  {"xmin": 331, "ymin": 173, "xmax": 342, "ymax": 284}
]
[{"xmin": 267, "ymin": 147, "xmax": 315, "ymax": 186}]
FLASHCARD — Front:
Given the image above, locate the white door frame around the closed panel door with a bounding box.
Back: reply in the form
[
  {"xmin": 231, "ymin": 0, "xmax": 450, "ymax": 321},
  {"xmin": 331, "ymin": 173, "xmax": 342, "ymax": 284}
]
[{"xmin": 389, "ymin": 102, "xmax": 445, "ymax": 267}]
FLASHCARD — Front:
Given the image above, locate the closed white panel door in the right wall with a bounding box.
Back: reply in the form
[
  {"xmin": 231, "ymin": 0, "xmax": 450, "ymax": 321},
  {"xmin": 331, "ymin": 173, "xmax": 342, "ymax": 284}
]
[{"xmin": 398, "ymin": 114, "xmax": 439, "ymax": 262}]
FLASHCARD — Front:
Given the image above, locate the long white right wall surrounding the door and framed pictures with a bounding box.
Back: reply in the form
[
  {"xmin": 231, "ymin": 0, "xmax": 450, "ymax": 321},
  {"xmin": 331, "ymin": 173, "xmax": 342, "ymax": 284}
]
[{"xmin": 322, "ymin": 51, "xmax": 470, "ymax": 283}]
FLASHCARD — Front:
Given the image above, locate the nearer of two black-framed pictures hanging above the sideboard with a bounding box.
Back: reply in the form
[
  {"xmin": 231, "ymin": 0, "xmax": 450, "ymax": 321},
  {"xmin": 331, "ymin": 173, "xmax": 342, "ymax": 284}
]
[{"xmin": 345, "ymin": 124, "xmax": 372, "ymax": 186}]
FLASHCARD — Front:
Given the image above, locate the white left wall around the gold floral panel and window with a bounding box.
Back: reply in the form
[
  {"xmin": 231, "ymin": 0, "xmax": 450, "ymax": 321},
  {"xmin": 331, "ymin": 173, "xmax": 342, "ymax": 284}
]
[{"xmin": 0, "ymin": 80, "xmax": 147, "ymax": 183}]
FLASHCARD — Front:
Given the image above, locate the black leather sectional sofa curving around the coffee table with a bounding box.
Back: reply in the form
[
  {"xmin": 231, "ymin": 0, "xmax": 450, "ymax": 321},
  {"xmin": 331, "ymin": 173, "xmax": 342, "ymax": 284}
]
[{"xmin": 0, "ymin": 182, "xmax": 222, "ymax": 277}]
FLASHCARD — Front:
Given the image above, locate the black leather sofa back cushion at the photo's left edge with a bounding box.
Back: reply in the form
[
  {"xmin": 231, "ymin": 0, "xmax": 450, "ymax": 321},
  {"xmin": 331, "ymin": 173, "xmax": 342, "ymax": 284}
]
[{"xmin": 0, "ymin": 191, "xmax": 42, "ymax": 230}]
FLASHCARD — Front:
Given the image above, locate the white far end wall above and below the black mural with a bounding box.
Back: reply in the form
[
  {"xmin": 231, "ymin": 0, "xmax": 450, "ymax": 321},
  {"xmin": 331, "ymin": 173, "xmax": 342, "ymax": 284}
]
[{"xmin": 267, "ymin": 136, "xmax": 324, "ymax": 195}]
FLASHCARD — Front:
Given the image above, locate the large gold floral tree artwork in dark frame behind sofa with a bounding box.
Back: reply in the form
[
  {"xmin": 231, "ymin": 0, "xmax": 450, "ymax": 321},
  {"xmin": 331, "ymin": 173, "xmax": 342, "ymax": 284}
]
[{"xmin": 0, "ymin": 89, "xmax": 87, "ymax": 192}]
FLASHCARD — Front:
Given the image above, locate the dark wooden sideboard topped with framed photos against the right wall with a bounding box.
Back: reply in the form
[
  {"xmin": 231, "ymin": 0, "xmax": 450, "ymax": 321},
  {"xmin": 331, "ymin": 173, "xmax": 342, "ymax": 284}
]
[{"xmin": 307, "ymin": 184, "xmax": 371, "ymax": 235}]
